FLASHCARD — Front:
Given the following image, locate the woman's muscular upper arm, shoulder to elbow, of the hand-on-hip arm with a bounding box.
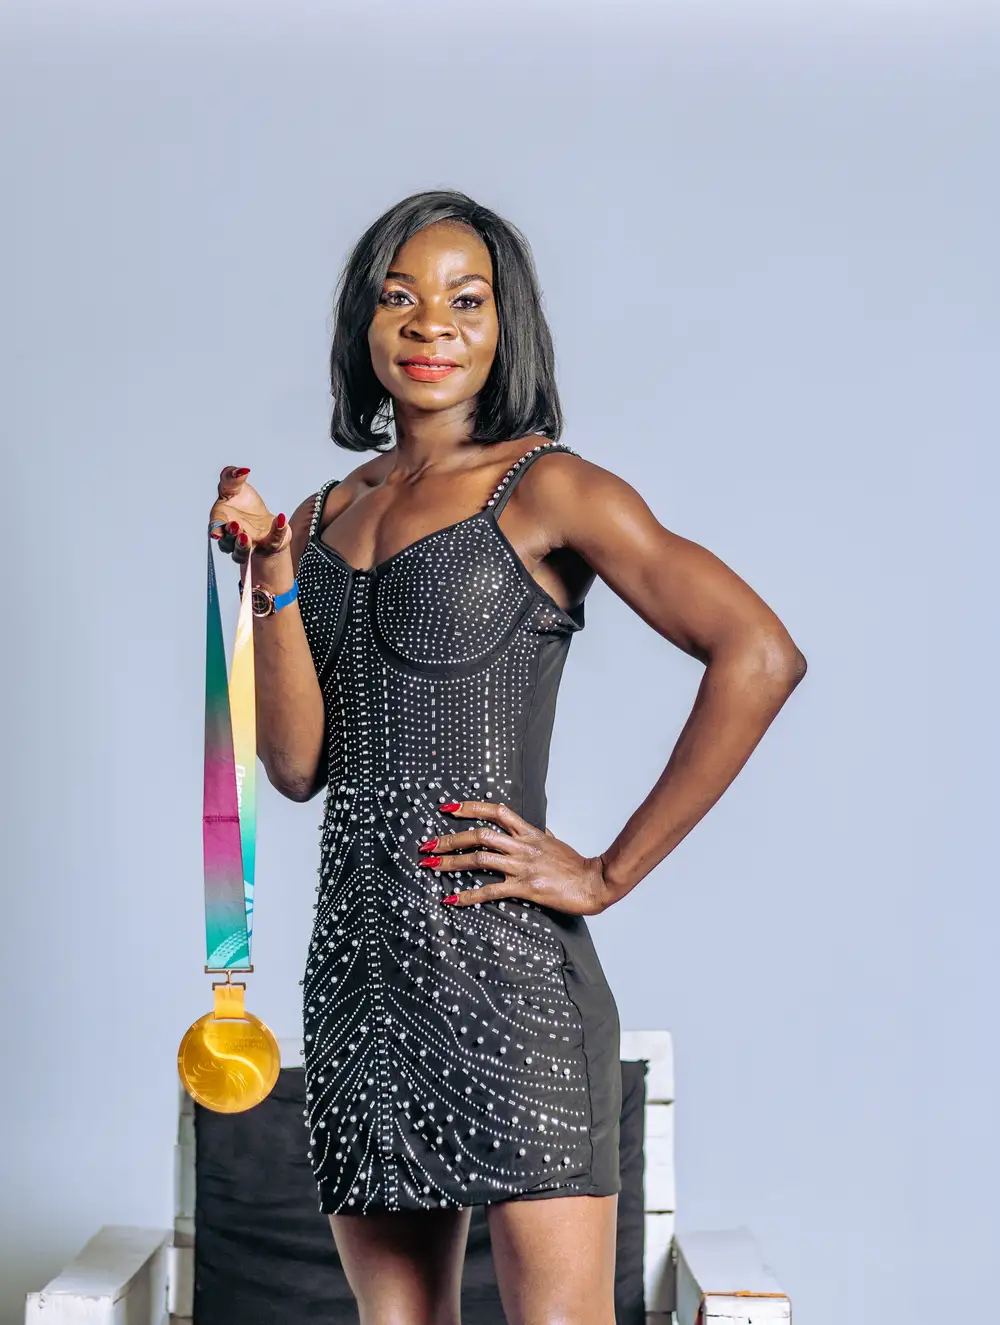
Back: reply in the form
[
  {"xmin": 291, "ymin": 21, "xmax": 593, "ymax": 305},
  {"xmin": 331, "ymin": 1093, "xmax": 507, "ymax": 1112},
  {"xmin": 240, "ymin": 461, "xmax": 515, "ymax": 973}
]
[{"xmin": 560, "ymin": 464, "xmax": 791, "ymax": 661}]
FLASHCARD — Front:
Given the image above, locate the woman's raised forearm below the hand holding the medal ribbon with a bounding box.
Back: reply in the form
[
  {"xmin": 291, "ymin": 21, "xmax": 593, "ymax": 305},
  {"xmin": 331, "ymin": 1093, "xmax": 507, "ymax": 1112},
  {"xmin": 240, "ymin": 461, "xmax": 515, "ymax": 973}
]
[{"xmin": 241, "ymin": 549, "xmax": 325, "ymax": 800}]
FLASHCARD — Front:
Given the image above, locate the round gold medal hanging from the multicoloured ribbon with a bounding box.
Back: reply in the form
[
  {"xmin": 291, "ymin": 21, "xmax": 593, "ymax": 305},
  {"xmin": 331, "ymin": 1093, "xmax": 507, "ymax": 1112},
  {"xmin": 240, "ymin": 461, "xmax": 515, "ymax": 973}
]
[{"xmin": 177, "ymin": 983, "xmax": 281, "ymax": 1113}]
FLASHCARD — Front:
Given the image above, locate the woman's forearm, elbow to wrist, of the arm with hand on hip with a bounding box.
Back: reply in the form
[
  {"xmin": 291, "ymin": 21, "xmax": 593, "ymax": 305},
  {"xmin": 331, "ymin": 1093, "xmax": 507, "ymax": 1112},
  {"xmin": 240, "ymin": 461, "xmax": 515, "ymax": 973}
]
[{"xmin": 600, "ymin": 644, "xmax": 805, "ymax": 901}]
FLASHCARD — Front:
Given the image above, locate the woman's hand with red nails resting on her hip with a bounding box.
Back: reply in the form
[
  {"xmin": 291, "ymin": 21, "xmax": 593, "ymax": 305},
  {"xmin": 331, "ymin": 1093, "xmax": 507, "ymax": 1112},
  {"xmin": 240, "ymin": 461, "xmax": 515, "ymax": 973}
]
[{"xmin": 420, "ymin": 800, "xmax": 616, "ymax": 916}]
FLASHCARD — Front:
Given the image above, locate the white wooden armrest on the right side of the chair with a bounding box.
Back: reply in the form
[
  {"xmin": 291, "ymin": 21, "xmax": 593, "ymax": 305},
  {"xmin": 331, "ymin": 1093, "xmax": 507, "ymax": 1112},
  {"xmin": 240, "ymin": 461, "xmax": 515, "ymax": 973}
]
[{"xmin": 677, "ymin": 1228, "xmax": 792, "ymax": 1325}]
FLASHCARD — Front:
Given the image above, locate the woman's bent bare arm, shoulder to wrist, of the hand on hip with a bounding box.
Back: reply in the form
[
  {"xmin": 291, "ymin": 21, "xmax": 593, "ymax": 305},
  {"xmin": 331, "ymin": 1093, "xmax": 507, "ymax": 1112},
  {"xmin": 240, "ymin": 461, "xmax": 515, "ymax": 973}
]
[{"xmin": 532, "ymin": 456, "xmax": 805, "ymax": 901}]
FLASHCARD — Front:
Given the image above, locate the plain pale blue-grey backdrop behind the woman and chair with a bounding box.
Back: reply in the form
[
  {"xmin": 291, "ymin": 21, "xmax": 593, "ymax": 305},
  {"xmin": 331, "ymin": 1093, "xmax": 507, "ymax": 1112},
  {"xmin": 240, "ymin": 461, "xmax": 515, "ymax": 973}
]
[{"xmin": 0, "ymin": 0, "xmax": 1000, "ymax": 1325}]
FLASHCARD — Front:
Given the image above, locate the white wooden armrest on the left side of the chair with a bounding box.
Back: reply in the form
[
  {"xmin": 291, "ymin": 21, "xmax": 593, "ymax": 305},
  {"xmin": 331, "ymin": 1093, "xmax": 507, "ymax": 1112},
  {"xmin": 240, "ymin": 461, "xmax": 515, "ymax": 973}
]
[{"xmin": 24, "ymin": 1224, "xmax": 170, "ymax": 1325}]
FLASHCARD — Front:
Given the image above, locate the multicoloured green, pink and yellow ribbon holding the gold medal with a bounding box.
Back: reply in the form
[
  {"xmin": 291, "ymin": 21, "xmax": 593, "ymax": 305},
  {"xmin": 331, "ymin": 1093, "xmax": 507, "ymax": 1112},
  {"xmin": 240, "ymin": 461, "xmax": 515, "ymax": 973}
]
[{"xmin": 203, "ymin": 539, "xmax": 257, "ymax": 971}]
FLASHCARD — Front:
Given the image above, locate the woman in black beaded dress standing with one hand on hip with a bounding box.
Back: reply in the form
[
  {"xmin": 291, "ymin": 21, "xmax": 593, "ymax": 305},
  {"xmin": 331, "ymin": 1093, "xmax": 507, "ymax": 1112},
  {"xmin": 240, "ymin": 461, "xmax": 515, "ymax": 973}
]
[{"xmin": 211, "ymin": 191, "xmax": 805, "ymax": 1325}]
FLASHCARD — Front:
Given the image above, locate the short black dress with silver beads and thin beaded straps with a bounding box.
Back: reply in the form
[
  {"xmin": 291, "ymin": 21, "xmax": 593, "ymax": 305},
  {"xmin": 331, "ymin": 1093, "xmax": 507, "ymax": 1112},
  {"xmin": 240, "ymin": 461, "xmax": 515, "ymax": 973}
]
[{"xmin": 298, "ymin": 443, "xmax": 621, "ymax": 1214}]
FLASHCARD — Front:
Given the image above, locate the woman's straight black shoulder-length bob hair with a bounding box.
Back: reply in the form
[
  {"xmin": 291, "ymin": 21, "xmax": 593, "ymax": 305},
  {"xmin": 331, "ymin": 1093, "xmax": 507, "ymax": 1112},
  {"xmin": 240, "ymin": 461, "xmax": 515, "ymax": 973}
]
[{"xmin": 330, "ymin": 188, "xmax": 563, "ymax": 451}]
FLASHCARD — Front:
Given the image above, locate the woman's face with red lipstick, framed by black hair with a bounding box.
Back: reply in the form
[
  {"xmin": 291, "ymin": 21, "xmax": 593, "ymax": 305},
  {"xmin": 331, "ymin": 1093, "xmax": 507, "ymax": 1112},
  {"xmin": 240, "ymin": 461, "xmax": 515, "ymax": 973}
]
[{"xmin": 368, "ymin": 221, "xmax": 499, "ymax": 411}]
